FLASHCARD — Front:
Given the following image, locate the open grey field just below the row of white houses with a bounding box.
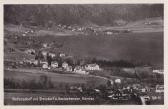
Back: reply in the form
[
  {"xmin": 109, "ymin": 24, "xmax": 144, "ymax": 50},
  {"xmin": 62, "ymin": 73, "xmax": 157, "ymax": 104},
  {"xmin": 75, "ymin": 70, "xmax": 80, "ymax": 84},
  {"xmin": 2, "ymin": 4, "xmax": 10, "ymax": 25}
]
[{"xmin": 4, "ymin": 69, "xmax": 107, "ymax": 86}]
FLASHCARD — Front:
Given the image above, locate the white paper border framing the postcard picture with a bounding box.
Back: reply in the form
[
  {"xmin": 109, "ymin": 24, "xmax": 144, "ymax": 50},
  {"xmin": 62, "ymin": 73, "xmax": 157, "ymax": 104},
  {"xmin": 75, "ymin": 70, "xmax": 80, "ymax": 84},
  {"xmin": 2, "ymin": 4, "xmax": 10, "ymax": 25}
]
[{"xmin": 0, "ymin": 0, "xmax": 168, "ymax": 109}]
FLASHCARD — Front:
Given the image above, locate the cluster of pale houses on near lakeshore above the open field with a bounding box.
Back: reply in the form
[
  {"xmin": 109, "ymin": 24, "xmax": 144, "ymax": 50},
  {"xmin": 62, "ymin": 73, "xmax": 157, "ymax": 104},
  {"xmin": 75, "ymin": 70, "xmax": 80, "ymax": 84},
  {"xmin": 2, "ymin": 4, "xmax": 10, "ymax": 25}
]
[{"xmin": 22, "ymin": 49, "xmax": 101, "ymax": 74}]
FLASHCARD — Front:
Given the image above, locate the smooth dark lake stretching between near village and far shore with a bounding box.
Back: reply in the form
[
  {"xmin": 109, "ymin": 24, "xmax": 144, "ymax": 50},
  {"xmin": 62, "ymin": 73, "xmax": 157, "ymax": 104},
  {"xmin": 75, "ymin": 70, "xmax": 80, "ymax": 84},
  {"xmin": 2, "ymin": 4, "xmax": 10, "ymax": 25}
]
[{"xmin": 40, "ymin": 32, "xmax": 163, "ymax": 66}]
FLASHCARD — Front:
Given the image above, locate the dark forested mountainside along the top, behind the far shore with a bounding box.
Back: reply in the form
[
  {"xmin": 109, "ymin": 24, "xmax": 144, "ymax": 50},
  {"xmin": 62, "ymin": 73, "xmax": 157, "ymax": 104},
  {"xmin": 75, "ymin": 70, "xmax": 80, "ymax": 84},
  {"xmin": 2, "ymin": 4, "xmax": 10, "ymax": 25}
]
[{"xmin": 4, "ymin": 4, "xmax": 164, "ymax": 26}]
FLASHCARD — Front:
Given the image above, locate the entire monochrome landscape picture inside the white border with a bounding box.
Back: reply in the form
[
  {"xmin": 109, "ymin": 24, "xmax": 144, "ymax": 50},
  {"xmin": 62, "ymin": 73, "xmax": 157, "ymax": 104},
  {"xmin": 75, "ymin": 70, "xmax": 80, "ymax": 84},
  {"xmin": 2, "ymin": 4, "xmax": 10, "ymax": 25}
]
[{"xmin": 2, "ymin": 3, "xmax": 165, "ymax": 106}]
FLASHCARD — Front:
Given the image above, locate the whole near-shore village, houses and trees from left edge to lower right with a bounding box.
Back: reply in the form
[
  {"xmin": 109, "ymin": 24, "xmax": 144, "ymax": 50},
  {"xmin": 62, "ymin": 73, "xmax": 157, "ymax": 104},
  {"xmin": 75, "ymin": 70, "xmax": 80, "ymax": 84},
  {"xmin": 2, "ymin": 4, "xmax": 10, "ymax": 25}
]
[{"xmin": 5, "ymin": 37, "xmax": 164, "ymax": 104}]
